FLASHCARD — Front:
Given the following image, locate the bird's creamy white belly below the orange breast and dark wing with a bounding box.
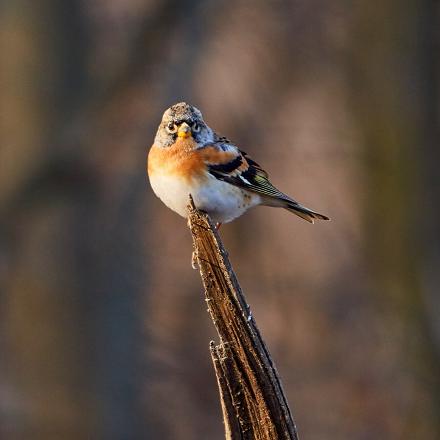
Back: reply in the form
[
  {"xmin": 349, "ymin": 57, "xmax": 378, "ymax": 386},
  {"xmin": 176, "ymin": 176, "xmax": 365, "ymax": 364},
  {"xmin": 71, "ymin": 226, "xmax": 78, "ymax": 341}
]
[{"xmin": 150, "ymin": 174, "xmax": 261, "ymax": 223}]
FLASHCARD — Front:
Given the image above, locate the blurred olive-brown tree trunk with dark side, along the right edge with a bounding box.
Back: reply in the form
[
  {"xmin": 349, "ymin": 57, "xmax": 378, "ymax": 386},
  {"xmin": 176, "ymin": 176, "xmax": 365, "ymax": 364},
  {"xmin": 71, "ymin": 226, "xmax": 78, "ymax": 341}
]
[{"xmin": 350, "ymin": 0, "xmax": 440, "ymax": 438}]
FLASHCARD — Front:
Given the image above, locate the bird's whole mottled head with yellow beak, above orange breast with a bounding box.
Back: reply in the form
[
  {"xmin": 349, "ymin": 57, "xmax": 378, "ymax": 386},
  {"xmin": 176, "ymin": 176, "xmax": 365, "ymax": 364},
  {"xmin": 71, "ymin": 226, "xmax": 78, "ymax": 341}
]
[{"xmin": 154, "ymin": 102, "xmax": 214, "ymax": 147}]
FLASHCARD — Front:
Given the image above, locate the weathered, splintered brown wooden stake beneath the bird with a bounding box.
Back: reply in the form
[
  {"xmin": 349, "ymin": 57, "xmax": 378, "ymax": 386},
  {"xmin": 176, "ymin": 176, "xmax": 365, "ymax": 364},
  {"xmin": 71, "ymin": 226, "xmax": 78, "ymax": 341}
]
[{"xmin": 188, "ymin": 200, "xmax": 298, "ymax": 440}]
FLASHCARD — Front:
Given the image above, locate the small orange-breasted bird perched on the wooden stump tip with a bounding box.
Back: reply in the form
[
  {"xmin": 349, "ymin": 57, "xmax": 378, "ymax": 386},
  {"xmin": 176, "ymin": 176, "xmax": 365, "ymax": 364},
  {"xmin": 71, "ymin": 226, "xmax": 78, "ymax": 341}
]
[{"xmin": 148, "ymin": 102, "xmax": 329, "ymax": 226}]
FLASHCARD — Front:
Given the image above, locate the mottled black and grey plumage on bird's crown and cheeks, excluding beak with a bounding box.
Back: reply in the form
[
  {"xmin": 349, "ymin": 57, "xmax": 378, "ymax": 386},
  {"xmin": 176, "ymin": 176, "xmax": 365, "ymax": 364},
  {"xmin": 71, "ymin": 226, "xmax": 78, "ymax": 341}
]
[{"xmin": 154, "ymin": 102, "xmax": 214, "ymax": 147}]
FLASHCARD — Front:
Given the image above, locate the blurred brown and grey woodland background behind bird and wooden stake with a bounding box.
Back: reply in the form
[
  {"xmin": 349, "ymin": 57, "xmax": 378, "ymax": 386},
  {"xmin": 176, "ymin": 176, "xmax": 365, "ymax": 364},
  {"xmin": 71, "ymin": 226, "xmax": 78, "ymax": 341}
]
[{"xmin": 0, "ymin": 0, "xmax": 440, "ymax": 440}]
